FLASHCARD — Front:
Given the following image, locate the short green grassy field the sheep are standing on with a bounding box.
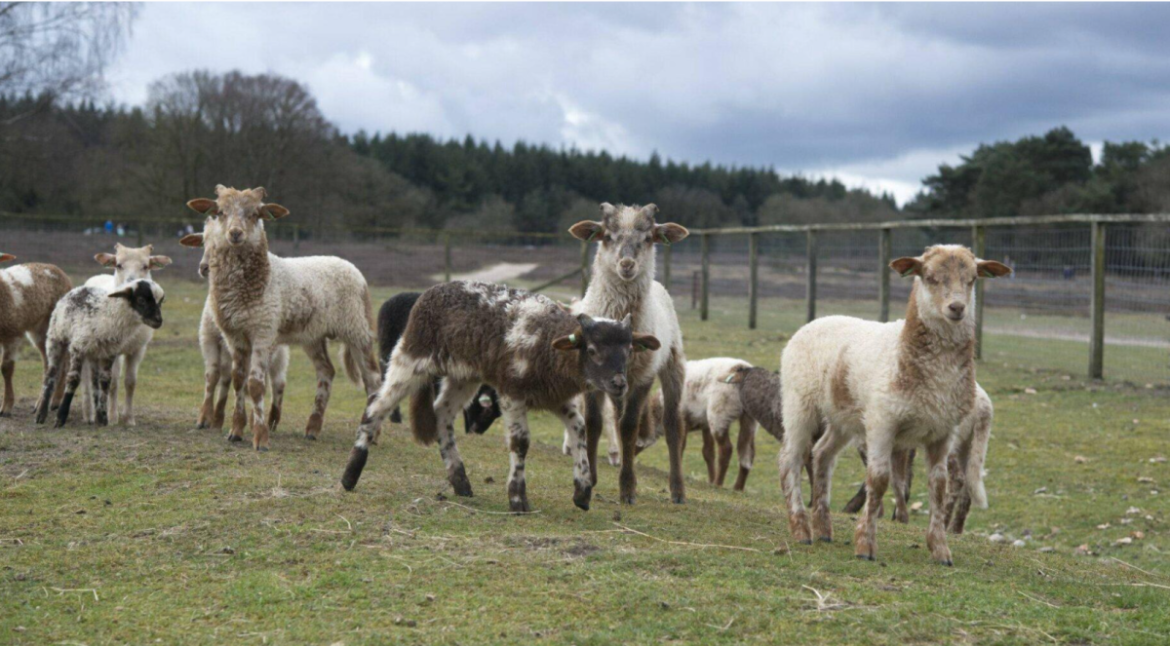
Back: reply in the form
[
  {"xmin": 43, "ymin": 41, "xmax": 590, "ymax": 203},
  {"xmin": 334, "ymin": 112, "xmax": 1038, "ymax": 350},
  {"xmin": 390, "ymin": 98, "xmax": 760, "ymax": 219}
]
[{"xmin": 0, "ymin": 281, "xmax": 1170, "ymax": 646}]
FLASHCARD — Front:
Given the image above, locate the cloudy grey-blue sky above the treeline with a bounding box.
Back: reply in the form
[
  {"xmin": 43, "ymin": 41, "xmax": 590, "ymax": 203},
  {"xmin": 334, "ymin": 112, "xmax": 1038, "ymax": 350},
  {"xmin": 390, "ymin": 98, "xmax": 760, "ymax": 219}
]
[{"xmin": 108, "ymin": 2, "xmax": 1170, "ymax": 202}]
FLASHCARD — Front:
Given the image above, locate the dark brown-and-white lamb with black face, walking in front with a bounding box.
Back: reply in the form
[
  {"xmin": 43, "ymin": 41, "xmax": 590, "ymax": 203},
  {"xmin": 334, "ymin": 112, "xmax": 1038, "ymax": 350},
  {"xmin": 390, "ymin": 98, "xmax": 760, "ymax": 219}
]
[{"xmin": 342, "ymin": 281, "xmax": 660, "ymax": 513}]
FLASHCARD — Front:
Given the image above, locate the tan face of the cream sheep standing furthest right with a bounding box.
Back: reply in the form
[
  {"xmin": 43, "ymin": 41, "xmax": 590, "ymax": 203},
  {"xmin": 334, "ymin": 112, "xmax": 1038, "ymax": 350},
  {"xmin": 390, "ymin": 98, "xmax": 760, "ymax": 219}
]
[{"xmin": 889, "ymin": 245, "xmax": 1012, "ymax": 323}]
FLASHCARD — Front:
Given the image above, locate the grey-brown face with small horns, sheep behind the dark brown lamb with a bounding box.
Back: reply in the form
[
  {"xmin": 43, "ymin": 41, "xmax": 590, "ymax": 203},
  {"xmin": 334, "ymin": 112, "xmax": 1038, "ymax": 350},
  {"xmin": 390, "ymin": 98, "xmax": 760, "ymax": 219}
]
[{"xmin": 569, "ymin": 204, "xmax": 688, "ymax": 282}]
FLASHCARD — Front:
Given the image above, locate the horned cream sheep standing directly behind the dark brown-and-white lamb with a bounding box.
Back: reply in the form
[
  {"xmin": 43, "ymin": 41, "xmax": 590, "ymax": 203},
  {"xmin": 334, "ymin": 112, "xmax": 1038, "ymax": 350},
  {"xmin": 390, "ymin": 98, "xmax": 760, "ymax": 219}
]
[{"xmin": 569, "ymin": 204, "xmax": 688, "ymax": 504}]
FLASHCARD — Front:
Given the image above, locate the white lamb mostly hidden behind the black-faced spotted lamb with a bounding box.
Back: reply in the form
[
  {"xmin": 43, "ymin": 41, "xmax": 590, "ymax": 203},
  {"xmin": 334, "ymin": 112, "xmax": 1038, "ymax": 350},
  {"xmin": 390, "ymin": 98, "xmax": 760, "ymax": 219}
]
[{"xmin": 81, "ymin": 242, "xmax": 171, "ymax": 426}]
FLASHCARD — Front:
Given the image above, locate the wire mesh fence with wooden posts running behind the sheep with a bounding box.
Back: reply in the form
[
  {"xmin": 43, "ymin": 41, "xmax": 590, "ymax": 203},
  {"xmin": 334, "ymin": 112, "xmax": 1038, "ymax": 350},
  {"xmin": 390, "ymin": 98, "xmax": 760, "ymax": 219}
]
[{"xmin": 0, "ymin": 214, "xmax": 1170, "ymax": 385}]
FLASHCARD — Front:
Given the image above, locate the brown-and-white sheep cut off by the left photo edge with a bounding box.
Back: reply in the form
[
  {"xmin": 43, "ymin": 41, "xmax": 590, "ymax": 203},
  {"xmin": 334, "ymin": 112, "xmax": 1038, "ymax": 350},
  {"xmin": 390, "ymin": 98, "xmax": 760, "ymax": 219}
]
[{"xmin": 0, "ymin": 253, "xmax": 73, "ymax": 417}]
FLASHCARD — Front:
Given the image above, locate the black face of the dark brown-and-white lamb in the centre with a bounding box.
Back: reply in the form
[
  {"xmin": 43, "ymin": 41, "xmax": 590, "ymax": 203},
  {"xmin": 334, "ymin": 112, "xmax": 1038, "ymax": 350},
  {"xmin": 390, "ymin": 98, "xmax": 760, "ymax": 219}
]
[{"xmin": 552, "ymin": 314, "xmax": 661, "ymax": 397}]
